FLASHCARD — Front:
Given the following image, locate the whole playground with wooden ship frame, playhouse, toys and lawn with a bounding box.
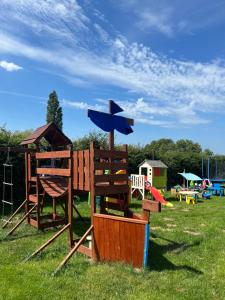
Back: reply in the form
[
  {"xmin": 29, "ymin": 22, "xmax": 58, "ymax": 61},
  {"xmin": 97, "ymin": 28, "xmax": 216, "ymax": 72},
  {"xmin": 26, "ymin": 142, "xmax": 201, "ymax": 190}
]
[{"xmin": 0, "ymin": 100, "xmax": 225, "ymax": 299}]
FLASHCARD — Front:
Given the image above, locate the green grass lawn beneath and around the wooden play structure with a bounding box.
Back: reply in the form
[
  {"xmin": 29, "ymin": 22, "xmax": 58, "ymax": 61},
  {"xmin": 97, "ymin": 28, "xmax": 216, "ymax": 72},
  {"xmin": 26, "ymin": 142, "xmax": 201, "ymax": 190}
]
[{"xmin": 0, "ymin": 197, "xmax": 225, "ymax": 300}]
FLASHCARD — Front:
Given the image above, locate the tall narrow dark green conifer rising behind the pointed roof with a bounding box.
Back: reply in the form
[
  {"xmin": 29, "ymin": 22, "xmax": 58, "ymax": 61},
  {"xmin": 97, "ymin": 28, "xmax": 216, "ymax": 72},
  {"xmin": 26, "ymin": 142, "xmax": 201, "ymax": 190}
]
[{"xmin": 46, "ymin": 91, "xmax": 63, "ymax": 129}]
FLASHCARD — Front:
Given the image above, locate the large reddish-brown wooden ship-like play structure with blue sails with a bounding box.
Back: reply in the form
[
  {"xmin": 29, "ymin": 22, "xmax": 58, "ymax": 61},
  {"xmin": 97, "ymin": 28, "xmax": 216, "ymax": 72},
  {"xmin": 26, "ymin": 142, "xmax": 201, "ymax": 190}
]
[{"xmin": 0, "ymin": 101, "xmax": 161, "ymax": 272}]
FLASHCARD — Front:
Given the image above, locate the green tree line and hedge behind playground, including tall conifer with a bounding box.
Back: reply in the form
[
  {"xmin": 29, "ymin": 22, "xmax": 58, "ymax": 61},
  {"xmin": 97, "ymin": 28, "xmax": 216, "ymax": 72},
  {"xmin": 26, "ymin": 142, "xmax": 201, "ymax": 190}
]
[{"xmin": 0, "ymin": 91, "xmax": 225, "ymax": 205}]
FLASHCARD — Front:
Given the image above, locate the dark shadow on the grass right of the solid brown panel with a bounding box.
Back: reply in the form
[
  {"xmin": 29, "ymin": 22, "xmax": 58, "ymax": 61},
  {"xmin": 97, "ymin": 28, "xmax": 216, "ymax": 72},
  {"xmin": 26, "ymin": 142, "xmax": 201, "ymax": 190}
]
[{"xmin": 148, "ymin": 234, "xmax": 203, "ymax": 275}]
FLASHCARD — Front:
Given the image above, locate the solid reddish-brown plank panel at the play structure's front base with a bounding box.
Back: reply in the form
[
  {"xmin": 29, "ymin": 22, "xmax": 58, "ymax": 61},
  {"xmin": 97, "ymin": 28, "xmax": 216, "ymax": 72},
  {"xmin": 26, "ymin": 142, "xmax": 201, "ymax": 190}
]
[{"xmin": 93, "ymin": 214, "xmax": 147, "ymax": 268}]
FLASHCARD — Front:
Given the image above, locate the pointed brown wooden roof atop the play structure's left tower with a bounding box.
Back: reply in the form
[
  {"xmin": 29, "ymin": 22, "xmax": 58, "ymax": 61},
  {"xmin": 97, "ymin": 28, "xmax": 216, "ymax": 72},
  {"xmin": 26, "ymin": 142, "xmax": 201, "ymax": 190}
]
[{"xmin": 21, "ymin": 122, "xmax": 72, "ymax": 146}]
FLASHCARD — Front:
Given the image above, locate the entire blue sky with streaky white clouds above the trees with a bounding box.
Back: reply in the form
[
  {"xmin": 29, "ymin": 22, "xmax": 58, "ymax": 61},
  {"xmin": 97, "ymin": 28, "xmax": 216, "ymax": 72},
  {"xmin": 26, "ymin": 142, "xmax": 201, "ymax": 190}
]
[{"xmin": 0, "ymin": 0, "xmax": 225, "ymax": 153}]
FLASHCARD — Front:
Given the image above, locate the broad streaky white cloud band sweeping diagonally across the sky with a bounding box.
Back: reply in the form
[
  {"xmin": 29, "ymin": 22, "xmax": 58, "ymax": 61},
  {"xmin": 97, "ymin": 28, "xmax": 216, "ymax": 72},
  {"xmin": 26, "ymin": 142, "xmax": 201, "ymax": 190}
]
[{"xmin": 0, "ymin": 0, "xmax": 225, "ymax": 127}]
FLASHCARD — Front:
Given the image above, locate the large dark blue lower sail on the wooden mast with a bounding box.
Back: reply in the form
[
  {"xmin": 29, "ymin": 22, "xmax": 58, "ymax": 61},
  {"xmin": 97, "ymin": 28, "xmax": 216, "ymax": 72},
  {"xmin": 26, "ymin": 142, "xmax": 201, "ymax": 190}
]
[{"xmin": 88, "ymin": 109, "xmax": 133, "ymax": 135}]
